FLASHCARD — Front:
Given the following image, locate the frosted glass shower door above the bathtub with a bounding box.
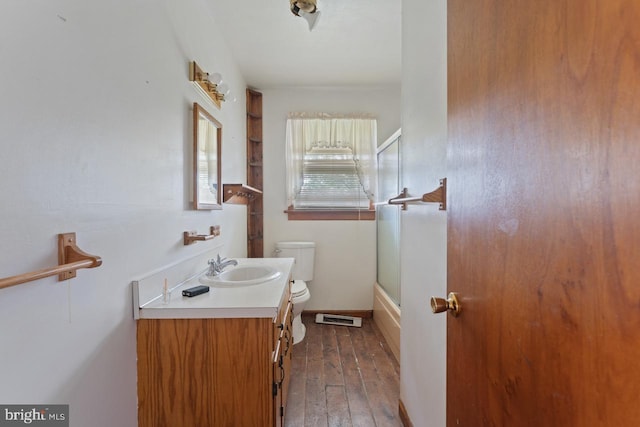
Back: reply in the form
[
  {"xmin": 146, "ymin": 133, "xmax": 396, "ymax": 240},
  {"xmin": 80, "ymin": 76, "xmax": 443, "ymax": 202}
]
[{"xmin": 376, "ymin": 131, "xmax": 400, "ymax": 306}]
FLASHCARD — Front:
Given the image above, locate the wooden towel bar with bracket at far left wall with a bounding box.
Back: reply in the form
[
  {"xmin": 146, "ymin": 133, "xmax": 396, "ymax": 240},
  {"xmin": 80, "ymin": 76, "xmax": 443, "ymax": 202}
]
[{"xmin": 0, "ymin": 233, "xmax": 102, "ymax": 289}]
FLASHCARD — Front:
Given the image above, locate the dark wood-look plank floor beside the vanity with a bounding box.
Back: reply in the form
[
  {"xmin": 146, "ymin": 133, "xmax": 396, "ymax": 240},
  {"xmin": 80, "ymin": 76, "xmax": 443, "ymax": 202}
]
[{"xmin": 285, "ymin": 315, "xmax": 402, "ymax": 427}]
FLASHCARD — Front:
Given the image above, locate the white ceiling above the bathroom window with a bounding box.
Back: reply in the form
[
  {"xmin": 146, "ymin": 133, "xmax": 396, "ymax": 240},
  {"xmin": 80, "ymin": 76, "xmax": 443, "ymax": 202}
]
[{"xmin": 206, "ymin": 0, "xmax": 401, "ymax": 89}]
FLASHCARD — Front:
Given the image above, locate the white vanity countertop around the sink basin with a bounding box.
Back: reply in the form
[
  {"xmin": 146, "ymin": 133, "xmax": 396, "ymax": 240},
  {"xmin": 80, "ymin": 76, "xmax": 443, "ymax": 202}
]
[{"xmin": 138, "ymin": 258, "xmax": 293, "ymax": 319}]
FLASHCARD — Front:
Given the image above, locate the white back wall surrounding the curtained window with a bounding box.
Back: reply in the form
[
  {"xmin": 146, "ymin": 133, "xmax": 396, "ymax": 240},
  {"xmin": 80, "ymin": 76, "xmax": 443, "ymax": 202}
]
[{"xmin": 261, "ymin": 86, "xmax": 400, "ymax": 310}]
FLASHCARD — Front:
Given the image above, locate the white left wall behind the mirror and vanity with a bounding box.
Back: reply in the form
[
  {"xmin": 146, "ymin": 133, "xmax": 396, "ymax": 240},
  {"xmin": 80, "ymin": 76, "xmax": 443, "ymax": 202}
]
[{"xmin": 0, "ymin": 0, "xmax": 246, "ymax": 427}]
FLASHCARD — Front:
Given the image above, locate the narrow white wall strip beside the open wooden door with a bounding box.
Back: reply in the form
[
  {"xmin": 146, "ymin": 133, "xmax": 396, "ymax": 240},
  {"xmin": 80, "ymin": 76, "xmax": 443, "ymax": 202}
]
[{"xmin": 400, "ymin": 0, "xmax": 447, "ymax": 427}]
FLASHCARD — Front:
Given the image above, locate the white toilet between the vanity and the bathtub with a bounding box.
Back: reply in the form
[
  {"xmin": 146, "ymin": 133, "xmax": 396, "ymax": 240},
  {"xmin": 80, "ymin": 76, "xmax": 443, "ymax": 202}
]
[{"xmin": 276, "ymin": 242, "xmax": 316, "ymax": 344}]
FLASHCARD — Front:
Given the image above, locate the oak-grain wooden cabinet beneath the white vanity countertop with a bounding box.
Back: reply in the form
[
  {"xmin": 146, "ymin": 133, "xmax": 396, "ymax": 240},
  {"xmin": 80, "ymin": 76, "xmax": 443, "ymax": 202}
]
[{"xmin": 137, "ymin": 282, "xmax": 293, "ymax": 427}]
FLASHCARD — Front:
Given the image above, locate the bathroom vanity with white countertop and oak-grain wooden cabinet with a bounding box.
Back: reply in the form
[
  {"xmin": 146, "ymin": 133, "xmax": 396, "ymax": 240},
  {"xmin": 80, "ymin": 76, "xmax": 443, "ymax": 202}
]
[{"xmin": 134, "ymin": 258, "xmax": 293, "ymax": 427}]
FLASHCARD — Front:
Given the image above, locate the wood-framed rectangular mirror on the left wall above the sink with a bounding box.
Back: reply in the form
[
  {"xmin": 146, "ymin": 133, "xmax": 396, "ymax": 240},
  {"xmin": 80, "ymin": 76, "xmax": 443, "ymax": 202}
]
[{"xmin": 193, "ymin": 102, "xmax": 222, "ymax": 209}]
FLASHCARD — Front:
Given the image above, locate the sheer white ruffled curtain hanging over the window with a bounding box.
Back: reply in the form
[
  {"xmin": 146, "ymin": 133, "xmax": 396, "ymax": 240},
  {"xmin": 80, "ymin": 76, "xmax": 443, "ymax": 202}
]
[{"xmin": 286, "ymin": 113, "xmax": 378, "ymax": 206}]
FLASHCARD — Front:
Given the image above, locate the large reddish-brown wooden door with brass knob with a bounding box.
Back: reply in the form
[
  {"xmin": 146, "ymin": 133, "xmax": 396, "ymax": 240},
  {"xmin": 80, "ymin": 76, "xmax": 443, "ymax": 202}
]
[{"xmin": 447, "ymin": 0, "xmax": 640, "ymax": 427}]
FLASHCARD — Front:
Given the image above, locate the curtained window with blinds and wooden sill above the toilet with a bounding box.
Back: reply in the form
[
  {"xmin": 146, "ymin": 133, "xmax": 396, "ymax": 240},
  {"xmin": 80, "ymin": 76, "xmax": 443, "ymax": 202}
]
[{"xmin": 286, "ymin": 113, "xmax": 377, "ymax": 220}]
